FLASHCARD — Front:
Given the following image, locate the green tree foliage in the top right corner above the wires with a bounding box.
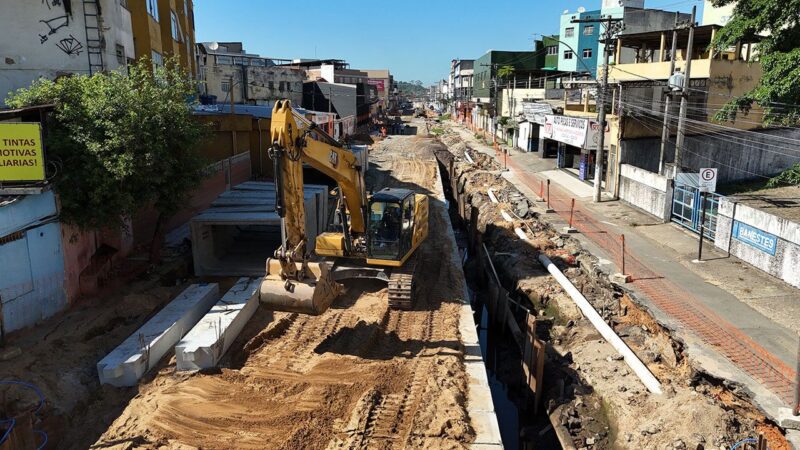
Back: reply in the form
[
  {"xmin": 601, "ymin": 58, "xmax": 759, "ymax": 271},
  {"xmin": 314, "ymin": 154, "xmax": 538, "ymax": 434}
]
[{"xmin": 712, "ymin": 0, "xmax": 800, "ymax": 125}]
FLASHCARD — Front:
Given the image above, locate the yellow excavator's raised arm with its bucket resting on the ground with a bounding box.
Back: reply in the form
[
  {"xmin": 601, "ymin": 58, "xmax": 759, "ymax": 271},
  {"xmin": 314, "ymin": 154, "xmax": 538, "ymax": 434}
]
[{"xmin": 260, "ymin": 100, "xmax": 367, "ymax": 314}]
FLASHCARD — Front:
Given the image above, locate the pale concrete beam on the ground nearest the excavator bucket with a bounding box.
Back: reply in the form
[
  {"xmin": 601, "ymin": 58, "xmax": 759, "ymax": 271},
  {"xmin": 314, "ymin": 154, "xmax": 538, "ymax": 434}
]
[{"xmin": 175, "ymin": 278, "xmax": 262, "ymax": 370}]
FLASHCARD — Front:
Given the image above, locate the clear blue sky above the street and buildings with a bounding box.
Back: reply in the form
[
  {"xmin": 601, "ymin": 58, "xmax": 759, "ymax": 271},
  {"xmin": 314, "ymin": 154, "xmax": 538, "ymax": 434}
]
[{"xmin": 195, "ymin": 0, "xmax": 702, "ymax": 84}]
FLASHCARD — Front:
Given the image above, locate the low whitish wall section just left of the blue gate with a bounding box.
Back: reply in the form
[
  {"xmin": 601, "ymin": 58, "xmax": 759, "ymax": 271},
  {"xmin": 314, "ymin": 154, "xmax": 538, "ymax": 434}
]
[{"xmin": 619, "ymin": 164, "xmax": 672, "ymax": 222}]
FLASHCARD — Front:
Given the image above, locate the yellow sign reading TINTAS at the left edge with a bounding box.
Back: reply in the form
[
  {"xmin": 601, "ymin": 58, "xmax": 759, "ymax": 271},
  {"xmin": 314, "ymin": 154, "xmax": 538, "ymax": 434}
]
[{"xmin": 0, "ymin": 122, "xmax": 44, "ymax": 182}]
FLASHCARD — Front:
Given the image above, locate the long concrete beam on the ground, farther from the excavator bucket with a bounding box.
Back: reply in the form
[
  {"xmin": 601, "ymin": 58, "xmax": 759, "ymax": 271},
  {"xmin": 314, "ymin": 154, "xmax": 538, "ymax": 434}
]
[{"xmin": 97, "ymin": 283, "xmax": 219, "ymax": 386}]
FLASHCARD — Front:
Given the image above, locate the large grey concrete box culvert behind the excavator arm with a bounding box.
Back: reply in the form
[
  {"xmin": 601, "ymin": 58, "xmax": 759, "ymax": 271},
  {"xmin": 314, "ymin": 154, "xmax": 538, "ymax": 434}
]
[{"xmin": 190, "ymin": 181, "xmax": 330, "ymax": 277}]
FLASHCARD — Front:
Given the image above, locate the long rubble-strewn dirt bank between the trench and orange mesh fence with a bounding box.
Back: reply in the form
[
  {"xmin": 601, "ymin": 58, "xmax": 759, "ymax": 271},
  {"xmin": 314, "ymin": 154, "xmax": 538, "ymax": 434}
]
[{"xmin": 439, "ymin": 128, "xmax": 786, "ymax": 449}]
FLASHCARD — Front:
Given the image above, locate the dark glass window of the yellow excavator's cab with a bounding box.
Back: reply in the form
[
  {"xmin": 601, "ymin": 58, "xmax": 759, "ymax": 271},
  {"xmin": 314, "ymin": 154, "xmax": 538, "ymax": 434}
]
[{"xmin": 369, "ymin": 201, "xmax": 403, "ymax": 260}]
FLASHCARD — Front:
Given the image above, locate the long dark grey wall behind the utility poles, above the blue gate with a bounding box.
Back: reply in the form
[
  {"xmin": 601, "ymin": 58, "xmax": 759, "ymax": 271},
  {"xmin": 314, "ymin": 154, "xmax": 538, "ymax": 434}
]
[{"xmin": 621, "ymin": 128, "xmax": 800, "ymax": 183}]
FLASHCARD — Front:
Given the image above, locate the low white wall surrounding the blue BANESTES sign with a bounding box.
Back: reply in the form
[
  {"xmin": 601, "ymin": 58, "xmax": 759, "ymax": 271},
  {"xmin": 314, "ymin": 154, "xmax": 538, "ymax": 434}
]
[{"xmin": 714, "ymin": 198, "xmax": 800, "ymax": 288}]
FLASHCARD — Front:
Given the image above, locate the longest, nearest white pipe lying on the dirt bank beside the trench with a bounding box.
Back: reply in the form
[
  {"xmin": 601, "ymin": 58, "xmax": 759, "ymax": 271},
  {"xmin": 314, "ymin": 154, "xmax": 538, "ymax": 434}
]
[{"xmin": 539, "ymin": 253, "xmax": 661, "ymax": 394}]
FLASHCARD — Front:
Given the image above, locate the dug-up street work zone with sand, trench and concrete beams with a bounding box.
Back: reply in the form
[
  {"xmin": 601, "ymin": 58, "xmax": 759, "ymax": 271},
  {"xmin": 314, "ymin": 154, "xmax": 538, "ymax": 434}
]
[{"xmin": 0, "ymin": 117, "xmax": 792, "ymax": 450}]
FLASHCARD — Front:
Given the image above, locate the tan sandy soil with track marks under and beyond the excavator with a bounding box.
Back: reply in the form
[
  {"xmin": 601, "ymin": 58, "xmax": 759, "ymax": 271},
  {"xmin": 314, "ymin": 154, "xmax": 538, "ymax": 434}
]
[{"xmin": 92, "ymin": 132, "xmax": 473, "ymax": 449}]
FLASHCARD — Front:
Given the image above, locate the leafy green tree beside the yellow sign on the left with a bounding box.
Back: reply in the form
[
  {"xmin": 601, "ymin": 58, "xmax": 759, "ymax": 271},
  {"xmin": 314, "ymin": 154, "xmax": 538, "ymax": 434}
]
[{"xmin": 6, "ymin": 60, "xmax": 207, "ymax": 258}]
